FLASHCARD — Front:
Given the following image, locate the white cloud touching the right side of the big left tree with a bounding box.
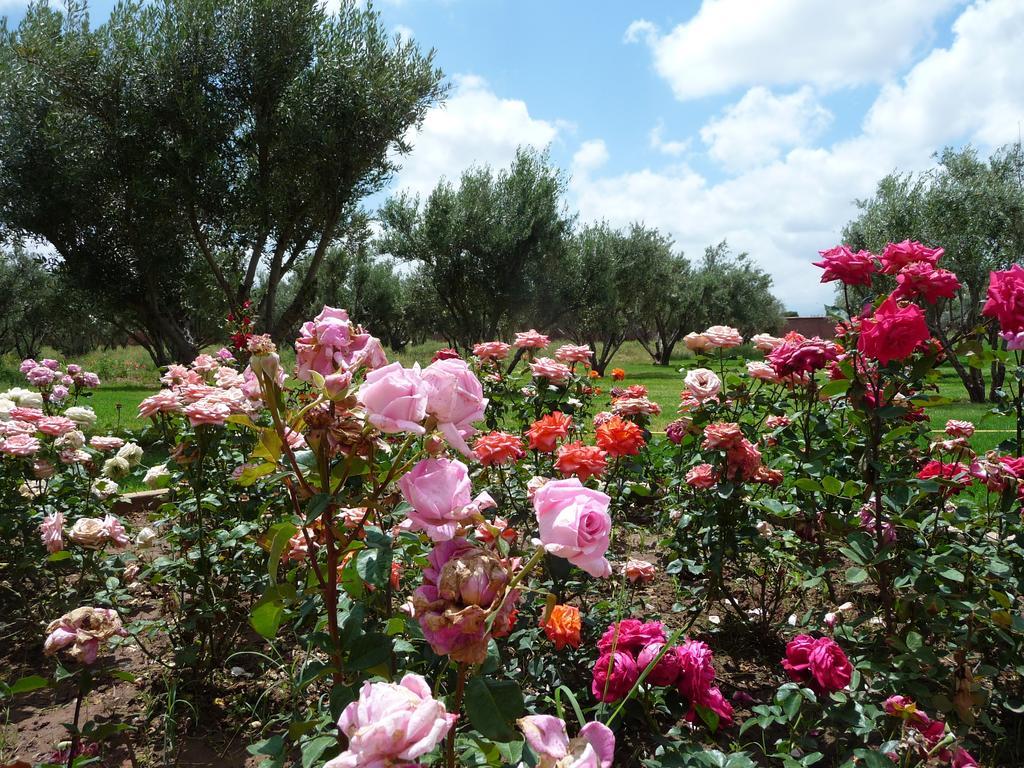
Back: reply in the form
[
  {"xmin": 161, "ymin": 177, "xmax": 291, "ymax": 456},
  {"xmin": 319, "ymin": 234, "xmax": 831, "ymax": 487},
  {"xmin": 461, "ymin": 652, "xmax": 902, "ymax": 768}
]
[{"xmin": 394, "ymin": 75, "xmax": 565, "ymax": 196}]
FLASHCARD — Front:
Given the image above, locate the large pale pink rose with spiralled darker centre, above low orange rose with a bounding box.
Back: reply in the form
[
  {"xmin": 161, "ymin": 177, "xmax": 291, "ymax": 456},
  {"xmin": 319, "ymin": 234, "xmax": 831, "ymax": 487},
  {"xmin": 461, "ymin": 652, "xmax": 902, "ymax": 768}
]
[{"xmin": 534, "ymin": 477, "xmax": 611, "ymax": 578}]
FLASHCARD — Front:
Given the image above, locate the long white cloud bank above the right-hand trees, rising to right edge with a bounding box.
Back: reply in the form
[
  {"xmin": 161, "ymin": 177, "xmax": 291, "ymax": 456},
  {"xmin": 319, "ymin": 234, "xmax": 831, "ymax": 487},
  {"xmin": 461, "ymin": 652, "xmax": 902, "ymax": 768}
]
[{"xmin": 571, "ymin": 0, "xmax": 1024, "ymax": 314}]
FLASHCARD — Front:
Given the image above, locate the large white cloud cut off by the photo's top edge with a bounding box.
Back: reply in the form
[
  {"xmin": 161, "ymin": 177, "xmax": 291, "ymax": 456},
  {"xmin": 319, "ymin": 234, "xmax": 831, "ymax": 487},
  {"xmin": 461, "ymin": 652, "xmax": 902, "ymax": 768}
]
[{"xmin": 625, "ymin": 0, "xmax": 962, "ymax": 100}]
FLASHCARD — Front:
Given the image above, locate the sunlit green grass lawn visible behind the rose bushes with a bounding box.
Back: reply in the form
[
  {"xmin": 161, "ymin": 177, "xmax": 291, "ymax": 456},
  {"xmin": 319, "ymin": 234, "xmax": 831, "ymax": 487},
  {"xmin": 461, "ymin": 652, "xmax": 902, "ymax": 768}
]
[{"xmin": 0, "ymin": 342, "xmax": 1014, "ymax": 452}]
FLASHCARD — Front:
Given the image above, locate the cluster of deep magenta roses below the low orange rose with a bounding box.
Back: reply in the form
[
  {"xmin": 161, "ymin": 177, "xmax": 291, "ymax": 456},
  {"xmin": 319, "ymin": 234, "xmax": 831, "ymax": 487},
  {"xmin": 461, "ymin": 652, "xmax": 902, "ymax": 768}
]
[{"xmin": 591, "ymin": 618, "xmax": 732, "ymax": 725}]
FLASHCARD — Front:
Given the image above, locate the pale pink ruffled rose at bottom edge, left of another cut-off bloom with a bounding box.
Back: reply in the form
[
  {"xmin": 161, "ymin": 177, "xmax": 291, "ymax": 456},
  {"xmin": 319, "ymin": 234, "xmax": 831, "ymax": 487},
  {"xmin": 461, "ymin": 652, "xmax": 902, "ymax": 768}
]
[{"xmin": 324, "ymin": 673, "xmax": 458, "ymax": 768}]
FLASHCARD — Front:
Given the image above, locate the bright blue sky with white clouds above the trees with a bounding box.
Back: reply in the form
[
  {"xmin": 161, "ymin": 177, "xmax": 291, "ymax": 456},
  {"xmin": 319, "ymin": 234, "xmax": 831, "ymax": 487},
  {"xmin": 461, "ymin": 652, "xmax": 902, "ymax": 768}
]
[{"xmin": 0, "ymin": 0, "xmax": 1024, "ymax": 314}]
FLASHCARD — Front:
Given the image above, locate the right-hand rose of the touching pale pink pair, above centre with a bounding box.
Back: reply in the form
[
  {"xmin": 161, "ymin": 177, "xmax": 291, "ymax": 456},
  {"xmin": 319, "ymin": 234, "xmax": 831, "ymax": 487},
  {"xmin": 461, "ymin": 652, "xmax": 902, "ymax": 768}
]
[{"xmin": 422, "ymin": 358, "xmax": 487, "ymax": 457}]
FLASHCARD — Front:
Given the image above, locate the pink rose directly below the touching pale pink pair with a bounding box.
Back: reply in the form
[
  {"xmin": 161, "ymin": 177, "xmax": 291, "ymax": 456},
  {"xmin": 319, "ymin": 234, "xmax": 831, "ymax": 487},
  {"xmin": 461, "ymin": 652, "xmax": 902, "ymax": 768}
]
[{"xmin": 398, "ymin": 459, "xmax": 479, "ymax": 542}]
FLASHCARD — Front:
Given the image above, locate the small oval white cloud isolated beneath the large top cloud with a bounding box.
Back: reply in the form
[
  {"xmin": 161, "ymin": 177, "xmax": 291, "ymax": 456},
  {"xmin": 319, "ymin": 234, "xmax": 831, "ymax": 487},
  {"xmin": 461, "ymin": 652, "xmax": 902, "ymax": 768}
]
[{"xmin": 700, "ymin": 86, "xmax": 833, "ymax": 171}]
